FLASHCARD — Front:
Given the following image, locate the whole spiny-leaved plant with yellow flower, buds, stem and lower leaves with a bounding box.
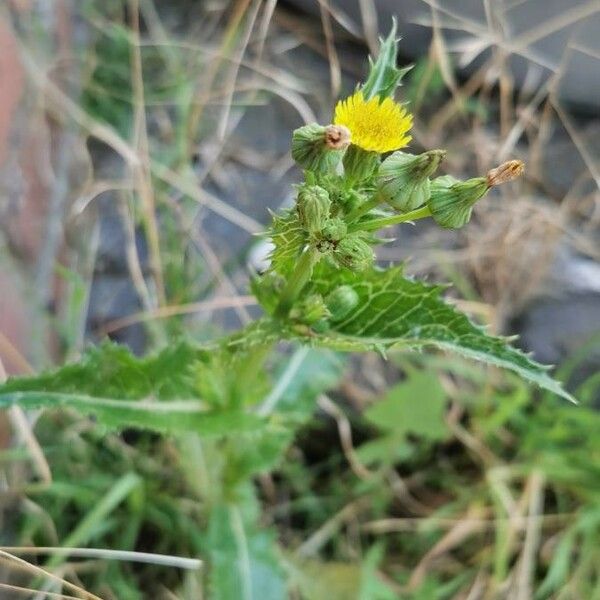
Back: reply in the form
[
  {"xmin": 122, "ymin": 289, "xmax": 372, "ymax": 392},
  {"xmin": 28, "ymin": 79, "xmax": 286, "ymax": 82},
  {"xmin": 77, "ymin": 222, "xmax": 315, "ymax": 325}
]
[{"xmin": 0, "ymin": 23, "xmax": 571, "ymax": 598}]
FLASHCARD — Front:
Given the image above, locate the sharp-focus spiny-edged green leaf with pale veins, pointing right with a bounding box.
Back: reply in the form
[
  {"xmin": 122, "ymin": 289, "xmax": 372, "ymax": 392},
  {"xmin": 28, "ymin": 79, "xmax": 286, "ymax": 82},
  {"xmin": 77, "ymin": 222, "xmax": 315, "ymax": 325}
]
[{"xmin": 289, "ymin": 261, "xmax": 574, "ymax": 401}]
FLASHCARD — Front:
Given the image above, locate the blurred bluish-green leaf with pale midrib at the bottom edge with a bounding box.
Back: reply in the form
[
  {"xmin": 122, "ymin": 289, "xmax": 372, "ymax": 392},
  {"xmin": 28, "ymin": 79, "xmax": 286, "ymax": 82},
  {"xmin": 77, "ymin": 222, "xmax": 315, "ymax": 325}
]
[{"xmin": 207, "ymin": 505, "xmax": 287, "ymax": 600}]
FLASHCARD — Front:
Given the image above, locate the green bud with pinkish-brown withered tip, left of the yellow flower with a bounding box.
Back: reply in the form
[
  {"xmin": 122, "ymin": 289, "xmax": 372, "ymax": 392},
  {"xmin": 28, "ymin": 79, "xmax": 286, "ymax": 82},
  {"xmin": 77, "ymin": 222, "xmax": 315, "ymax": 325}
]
[{"xmin": 292, "ymin": 123, "xmax": 350, "ymax": 173}]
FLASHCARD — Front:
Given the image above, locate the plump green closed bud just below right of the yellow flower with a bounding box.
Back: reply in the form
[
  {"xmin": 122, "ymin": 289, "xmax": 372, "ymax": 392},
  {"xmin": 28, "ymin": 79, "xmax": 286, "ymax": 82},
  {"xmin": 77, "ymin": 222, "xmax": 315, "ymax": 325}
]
[{"xmin": 377, "ymin": 150, "xmax": 446, "ymax": 212}]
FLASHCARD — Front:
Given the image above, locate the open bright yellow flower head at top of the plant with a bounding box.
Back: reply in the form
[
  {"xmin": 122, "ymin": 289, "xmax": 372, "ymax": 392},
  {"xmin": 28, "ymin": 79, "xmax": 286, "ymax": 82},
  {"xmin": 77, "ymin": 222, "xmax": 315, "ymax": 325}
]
[{"xmin": 333, "ymin": 92, "xmax": 412, "ymax": 154}]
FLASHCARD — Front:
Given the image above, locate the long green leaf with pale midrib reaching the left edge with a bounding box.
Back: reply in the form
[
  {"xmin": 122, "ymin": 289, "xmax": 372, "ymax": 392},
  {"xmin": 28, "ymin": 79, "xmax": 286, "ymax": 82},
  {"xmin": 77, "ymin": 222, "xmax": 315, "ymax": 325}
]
[{"xmin": 0, "ymin": 343, "xmax": 264, "ymax": 435}]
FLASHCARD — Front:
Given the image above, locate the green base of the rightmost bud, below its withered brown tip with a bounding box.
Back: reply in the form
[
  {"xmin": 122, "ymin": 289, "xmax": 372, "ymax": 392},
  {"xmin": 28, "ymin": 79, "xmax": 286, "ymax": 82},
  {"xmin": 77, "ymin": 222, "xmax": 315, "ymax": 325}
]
[{"xmin": 427, "ymin": 175, "xmax": 489, "ymax": 229}]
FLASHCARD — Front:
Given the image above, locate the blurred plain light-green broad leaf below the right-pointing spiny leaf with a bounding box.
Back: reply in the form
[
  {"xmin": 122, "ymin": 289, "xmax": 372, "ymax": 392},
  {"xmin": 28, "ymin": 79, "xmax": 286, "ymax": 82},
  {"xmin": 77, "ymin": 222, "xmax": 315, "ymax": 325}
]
[{"xmin": 365, "ymin": 371, "xmax": 448, "ymax": 440}]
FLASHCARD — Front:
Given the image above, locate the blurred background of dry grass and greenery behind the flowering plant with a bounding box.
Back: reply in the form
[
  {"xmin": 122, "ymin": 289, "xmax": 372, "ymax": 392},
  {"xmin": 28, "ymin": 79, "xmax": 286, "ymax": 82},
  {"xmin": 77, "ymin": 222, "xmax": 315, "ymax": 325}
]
[{"xmin": 0, "ymin": 0, "xmax": 600, "ymax": 600}]
